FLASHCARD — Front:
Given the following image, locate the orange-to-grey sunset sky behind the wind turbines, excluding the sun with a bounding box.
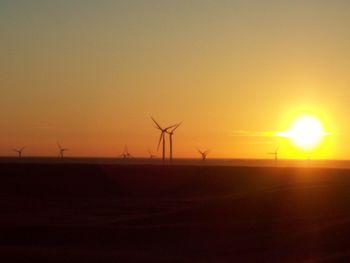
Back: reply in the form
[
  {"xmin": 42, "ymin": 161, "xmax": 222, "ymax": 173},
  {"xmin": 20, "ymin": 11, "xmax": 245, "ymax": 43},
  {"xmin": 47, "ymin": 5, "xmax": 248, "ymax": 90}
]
[{"xmin": 0, "ymin": 0, "xmax": 350, "ymax": 159}]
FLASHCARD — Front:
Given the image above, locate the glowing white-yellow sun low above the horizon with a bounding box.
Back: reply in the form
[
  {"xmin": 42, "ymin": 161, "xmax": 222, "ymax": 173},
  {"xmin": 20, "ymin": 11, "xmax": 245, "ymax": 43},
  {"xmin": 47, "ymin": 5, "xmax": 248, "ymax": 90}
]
[{"xmin": 278, "ymin": 115, "xmax": 327, "ymax": 150}]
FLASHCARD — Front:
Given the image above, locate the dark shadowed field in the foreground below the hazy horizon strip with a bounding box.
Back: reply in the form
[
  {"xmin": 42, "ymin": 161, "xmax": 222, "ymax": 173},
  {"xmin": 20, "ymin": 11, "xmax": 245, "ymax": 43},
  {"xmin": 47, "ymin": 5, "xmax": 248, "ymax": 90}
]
[{"xmin": 0, "ymin": 163, "xmax": 350, "ymax": 262}]
